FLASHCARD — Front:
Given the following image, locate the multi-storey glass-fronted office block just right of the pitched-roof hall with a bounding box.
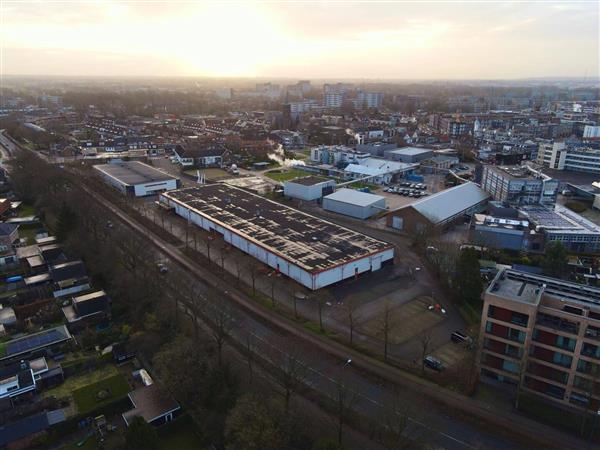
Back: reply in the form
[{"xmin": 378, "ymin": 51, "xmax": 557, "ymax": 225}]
[{"xmin": 481, "ymin": 165, "xmax": 560, "ymax": 206}]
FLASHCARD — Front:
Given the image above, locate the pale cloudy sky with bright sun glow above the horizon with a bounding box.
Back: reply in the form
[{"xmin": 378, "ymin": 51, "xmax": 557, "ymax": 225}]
[{"xmin": 0, "ymin": 0, "xmax": 600, "ymax": 80}]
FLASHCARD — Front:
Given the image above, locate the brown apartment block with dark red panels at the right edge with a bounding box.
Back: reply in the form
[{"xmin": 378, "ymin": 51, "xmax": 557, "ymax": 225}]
[{"xmin": 478, "ymin": 269, "xmax": 600, "ymax": 409}]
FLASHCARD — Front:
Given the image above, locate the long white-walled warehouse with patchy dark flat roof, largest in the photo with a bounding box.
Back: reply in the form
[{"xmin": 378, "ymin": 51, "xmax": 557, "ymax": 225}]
[{"xmin": 160, "ymin": 184, "xmax": 394, "ymax": 290}]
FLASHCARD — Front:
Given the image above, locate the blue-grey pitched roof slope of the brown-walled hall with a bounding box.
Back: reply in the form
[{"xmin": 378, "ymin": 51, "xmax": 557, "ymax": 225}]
[{"xmin": 406, "ymin": 182, "xmax": 490, "ymax": 224}]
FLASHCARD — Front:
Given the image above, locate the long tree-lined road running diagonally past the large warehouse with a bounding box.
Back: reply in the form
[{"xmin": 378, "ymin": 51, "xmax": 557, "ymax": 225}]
[{"xmin": 0, "ymin": 132, "xmax": 583, "ymax": 449}]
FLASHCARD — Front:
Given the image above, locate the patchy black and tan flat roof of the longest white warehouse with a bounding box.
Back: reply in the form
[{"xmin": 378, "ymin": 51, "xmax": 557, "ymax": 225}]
[{"xmin": 161, "ymin": 184, "xmax": 393, "ymax": 273}]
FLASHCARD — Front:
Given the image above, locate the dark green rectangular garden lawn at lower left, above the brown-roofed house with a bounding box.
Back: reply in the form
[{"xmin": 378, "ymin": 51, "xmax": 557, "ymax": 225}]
[{"xmin": 73, "ymin": 374, "xmax": 131, "ymax": 414}]
